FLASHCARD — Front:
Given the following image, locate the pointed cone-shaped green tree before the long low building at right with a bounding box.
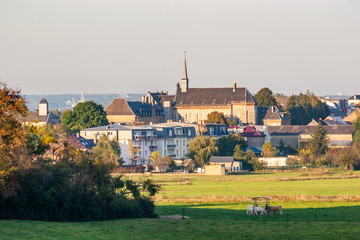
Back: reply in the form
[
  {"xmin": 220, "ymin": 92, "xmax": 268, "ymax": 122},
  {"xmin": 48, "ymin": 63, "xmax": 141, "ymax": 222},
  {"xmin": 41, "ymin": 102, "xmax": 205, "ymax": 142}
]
[{"xmin": 309, "ymin": 123, "xmax": 329, "ymax": 155}]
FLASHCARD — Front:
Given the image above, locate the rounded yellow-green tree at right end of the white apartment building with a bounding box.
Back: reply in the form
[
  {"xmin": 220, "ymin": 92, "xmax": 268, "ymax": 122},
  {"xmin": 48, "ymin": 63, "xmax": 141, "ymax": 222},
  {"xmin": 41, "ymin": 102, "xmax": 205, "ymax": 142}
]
[{"xmin": 187, "ymin": 136, "xmax": 218, "ymax": 166}]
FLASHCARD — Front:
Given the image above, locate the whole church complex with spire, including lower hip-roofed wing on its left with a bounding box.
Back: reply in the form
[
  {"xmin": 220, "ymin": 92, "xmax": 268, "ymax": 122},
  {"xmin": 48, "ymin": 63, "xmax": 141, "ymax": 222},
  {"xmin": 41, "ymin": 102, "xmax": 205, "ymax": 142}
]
[{"xmin": 105, "ymin": 56, "xmax": 258, "ymax": 125}]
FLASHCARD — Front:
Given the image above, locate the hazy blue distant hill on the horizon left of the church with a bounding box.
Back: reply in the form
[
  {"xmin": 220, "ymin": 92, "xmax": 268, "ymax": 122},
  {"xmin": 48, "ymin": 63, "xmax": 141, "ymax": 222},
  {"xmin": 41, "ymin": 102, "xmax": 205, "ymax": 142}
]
[{"xmin": 24, "ymin": 93, "xmax": 145, "ymax": 110}]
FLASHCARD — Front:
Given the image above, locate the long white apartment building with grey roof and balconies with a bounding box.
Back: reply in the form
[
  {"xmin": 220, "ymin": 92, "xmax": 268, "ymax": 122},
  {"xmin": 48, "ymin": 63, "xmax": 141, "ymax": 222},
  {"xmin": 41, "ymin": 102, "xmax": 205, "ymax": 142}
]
[{"xmin": 80, "ymin": 123, "xmax": 196, "ymax": 165}]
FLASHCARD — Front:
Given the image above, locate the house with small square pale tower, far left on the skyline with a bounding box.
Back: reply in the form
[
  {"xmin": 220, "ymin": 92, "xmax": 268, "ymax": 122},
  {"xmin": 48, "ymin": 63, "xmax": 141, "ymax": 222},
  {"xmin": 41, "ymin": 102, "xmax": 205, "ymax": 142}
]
[{"xmin": 20, "ymin": 97, "xmax": 60, "ymax": 126}]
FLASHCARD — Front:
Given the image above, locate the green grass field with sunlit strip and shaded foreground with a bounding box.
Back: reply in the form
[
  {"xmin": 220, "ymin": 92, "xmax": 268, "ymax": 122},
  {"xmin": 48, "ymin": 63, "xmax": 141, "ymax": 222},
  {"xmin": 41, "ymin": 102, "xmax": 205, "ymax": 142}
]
[{"xmin": 0, "ymin": 171, "xmax": 360, "ymax": 239}]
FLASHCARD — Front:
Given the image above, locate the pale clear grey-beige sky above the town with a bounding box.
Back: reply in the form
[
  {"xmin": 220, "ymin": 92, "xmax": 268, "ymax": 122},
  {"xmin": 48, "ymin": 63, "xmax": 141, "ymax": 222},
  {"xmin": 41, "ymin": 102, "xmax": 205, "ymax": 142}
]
[{"xmin": 0, "ymin": 0, "xmax": 360, "ymax": 95}]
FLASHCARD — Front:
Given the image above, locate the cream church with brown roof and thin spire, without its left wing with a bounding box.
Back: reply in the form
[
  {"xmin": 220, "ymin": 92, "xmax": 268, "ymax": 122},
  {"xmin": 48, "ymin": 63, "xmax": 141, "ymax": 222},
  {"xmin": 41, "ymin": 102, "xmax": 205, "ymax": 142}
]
[{"xmin": 173, "ymin": 54, "xmax": 257, "ymax": 124}]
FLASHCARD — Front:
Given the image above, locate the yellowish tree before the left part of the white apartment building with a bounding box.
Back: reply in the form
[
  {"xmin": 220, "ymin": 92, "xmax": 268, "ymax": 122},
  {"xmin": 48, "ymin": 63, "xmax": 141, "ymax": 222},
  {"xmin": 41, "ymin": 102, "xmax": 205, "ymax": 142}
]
[{"xmin": 93, "ymin": 135, "xmax": 121, "ymax": 168}]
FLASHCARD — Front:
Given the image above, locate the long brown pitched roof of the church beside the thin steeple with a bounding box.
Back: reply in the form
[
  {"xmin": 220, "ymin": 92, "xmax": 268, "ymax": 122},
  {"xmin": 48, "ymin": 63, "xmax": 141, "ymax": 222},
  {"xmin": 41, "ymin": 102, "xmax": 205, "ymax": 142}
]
[{"xmin": 175, "ymin": 88, "xmax": 255, "ymax": 106}]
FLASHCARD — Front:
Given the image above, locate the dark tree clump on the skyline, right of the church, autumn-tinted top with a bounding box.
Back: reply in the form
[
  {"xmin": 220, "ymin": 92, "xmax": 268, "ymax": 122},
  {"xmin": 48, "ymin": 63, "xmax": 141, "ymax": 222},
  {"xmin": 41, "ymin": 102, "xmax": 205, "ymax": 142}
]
[{"xmin": 287, "ymin": 91, "xmax": 330, "ymax": 125}]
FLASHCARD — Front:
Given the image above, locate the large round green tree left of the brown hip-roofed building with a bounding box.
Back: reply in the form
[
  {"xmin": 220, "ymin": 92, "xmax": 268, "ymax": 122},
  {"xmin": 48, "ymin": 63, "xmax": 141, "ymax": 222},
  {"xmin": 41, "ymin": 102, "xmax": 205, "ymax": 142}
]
[{"xmin": 62, "ymin": 101, "xmax": 109, "ymax": 133}]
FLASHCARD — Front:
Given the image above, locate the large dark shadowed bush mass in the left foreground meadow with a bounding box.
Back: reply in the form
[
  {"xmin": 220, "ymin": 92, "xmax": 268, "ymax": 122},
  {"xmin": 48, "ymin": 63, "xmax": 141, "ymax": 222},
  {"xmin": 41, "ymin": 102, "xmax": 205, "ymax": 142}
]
[{"xmin": 0, "ymin": 144, "xmax": 159, "ymax": 221}]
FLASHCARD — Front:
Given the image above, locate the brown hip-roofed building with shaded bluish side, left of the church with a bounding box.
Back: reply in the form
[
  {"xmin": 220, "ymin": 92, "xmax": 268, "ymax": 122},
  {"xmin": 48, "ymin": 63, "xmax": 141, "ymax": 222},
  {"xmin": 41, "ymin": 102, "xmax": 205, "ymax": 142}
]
[{"xmin": 105, "ymin": 98, "xmax": 164, "ymax": 124}]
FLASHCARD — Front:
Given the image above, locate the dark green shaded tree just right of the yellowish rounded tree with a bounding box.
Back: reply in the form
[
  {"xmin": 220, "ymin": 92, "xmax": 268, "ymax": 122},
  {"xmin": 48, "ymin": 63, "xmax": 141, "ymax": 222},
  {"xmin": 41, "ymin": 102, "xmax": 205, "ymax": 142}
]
[{"xmin": 216, "ymin": 133, "xmax": 247, "ymax": 156}]
